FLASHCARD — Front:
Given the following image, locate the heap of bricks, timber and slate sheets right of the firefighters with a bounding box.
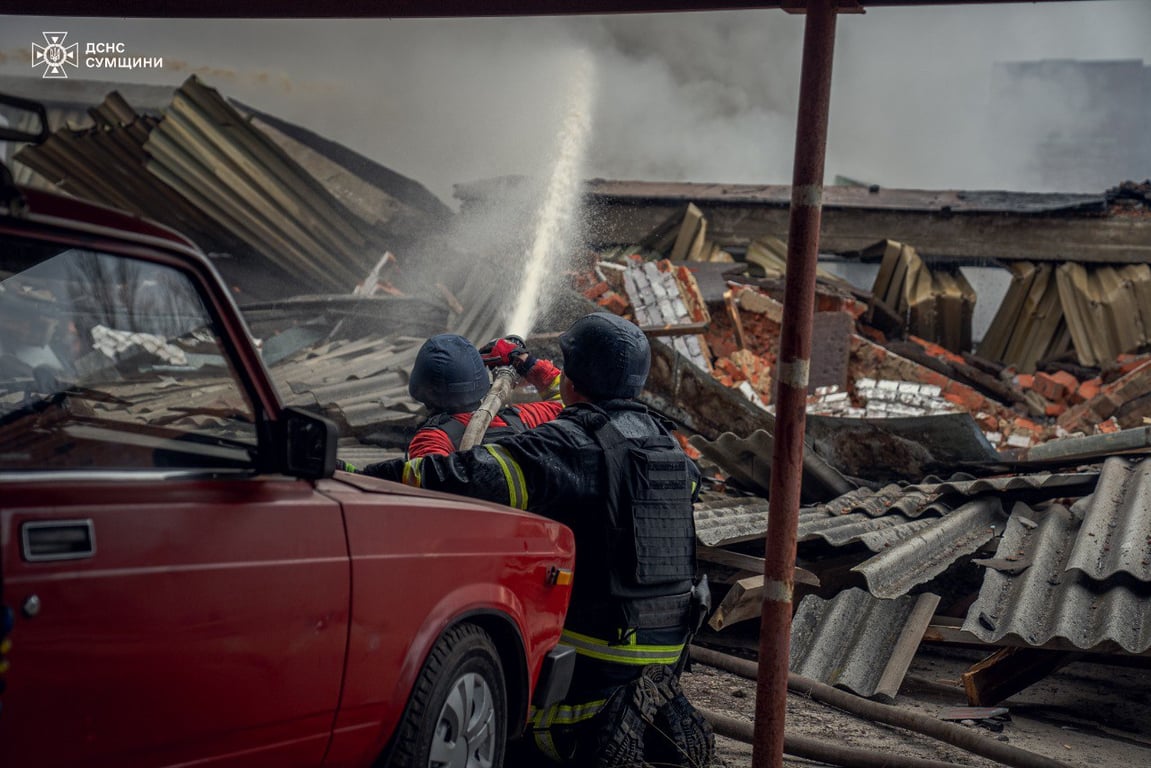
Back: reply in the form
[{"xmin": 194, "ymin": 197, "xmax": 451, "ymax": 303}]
[{"xmin": 561, "ymin": 203, "xmax": 1151, "ymax": 706}]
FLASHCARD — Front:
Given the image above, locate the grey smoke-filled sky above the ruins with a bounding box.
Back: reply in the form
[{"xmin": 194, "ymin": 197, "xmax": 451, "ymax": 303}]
[{"xmin": 0, "ymin": 0, "xmax": 1151, "ymax": 207}]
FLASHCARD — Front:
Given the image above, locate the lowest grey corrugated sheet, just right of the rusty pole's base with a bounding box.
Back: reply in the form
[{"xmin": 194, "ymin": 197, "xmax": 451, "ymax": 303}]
[{"xmin": 788, "ymin": 590, "xmax": 939, "ymax": 701}]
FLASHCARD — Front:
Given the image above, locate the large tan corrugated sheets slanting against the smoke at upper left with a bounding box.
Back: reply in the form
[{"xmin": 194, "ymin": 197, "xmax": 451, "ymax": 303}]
[{"xmin": 17, "ymin": 76, "xmax": 395, "ymax": 291}]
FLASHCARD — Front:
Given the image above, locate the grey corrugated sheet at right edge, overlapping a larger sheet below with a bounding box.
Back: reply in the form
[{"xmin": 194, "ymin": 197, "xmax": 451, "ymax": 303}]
[{"xmin": 1067, "ymin": 457, "xmax": 1151, "ymax": 581}]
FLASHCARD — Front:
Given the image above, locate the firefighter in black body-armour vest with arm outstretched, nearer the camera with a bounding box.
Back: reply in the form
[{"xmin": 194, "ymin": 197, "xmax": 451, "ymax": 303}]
[{"xmin": 376, "ymin": 312, "xmax": 714, "ymax": 768}]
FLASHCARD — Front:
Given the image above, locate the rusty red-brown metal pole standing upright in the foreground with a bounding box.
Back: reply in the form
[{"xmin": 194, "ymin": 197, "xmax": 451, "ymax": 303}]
[{"xmin": 752, "ymin": 0, "xmax": 838, "ymax": 768}]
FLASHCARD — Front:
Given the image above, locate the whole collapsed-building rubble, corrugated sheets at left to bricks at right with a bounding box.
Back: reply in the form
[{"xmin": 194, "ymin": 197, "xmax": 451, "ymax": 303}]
[{"xmin": 18, "ymin": 78, "xmax": 1151, "ymax": 718}]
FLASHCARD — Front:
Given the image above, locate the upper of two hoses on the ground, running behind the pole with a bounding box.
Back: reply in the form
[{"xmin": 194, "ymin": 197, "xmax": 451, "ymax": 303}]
[{"xmin": 691, "ymin": 645, "xmax": 1074, "ymax": 768}]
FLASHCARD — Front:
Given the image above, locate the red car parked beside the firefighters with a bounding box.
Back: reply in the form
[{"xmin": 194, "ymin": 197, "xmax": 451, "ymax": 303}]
[{"xmin": 0, "ymin": 98, "xmax": 574, "ymax": 768}]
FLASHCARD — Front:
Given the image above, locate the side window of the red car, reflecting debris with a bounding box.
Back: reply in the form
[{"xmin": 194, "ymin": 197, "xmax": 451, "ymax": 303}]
[{"xmin": 0, "ymin": 236, "xmax": 257, "ymax": 470}]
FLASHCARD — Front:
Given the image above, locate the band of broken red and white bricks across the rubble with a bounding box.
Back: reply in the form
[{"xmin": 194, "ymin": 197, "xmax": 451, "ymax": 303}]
[{"xmin": 571, "ymin": 254, "xmax": 1151, "ymax": 448}]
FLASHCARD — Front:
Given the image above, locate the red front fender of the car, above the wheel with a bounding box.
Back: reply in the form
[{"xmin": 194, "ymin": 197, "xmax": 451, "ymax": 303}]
[{"xmin": 320, "ymin": 472, "xmax": 574, "ymax": 765}]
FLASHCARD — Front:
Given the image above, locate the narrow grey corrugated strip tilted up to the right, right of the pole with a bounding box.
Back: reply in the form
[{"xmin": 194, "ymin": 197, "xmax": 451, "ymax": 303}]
[{"xmin": 852, "ymin": 496, "xmax": 1006, "ymax": 598}]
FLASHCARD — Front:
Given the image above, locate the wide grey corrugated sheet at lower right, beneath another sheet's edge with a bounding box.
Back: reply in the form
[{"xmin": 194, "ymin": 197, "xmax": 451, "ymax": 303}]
[{"xmin": 963, "ymin": 499, "xmax": 1151, "ymax": 653}]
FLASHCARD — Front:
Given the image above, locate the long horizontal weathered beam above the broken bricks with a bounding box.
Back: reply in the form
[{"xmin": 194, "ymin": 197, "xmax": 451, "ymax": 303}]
[{"xmin": 584, "ymin": 182, "xmax": 1151, "ymax": 264}]
